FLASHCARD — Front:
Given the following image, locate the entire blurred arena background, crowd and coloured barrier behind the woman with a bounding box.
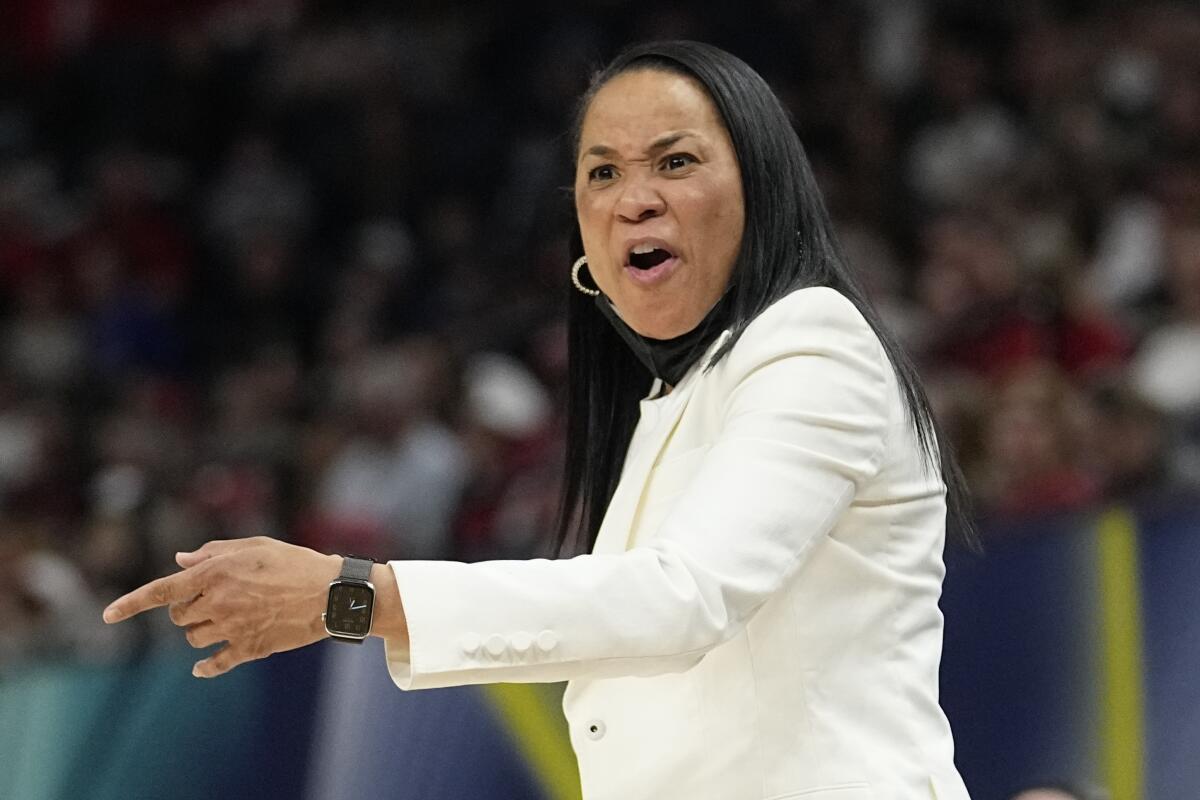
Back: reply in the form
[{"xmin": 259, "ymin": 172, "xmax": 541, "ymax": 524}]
[{"xmin": 0, "ymin": 0, "xmax": 1200, "ymax": 800}]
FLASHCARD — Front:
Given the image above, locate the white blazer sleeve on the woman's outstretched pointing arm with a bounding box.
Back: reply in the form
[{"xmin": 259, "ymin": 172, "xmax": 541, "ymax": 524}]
[{"xmin": 388, "ymin": 288, "xmax": 896, "ymax": 688}]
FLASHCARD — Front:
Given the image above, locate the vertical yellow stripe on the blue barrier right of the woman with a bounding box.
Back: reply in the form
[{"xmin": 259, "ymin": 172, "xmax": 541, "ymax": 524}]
[{"xmin": 1097, "ymin": 509, "xmax": 1145, "ymax": 800}]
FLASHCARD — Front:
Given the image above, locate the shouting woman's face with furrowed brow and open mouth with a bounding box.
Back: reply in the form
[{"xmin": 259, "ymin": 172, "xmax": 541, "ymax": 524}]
[{"xmin": 575, "ymin": 68, "xmax": 745, "ymax": 339}]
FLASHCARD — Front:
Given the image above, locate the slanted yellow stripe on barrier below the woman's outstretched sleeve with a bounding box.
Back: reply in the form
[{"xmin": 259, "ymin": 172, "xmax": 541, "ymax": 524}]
[{"xmin": 485, "ymin": 684, "xmax": 583, "ymax": 800}]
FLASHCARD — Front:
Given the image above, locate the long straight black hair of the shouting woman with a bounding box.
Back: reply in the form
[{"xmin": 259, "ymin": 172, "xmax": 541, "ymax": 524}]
[{"xmin": 557, "ymin": 41, "xmax": 974, "ymax": 554}]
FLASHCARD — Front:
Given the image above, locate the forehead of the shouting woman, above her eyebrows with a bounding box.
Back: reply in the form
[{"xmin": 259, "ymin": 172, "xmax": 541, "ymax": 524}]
[{"xmin": 580, "ymin": 68, "xmax": 728, "ymax": 154}]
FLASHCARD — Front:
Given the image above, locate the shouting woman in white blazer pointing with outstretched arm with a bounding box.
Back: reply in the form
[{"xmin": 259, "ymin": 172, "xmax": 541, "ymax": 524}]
[{"xmin": 106, "ymin": 42, "xmax": 967, "ymax": 800}]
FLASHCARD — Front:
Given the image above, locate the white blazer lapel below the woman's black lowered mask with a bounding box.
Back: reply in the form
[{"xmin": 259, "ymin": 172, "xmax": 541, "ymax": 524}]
[{"xmin": 592, "ymin": 331, "xmax": 730, "ymax": 554}]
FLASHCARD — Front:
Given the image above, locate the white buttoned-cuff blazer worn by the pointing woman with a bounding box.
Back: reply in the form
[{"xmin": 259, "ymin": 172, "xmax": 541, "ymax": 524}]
[{"xmin": 388, "ymin": 288, "xmax": 967, "ymax": 800}]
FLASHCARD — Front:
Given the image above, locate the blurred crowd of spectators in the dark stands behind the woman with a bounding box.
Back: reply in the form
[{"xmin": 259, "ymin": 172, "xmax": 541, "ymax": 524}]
[{"xmin": 0, "ymin": 0, "xmax": 1200, "ymax": 666}]
